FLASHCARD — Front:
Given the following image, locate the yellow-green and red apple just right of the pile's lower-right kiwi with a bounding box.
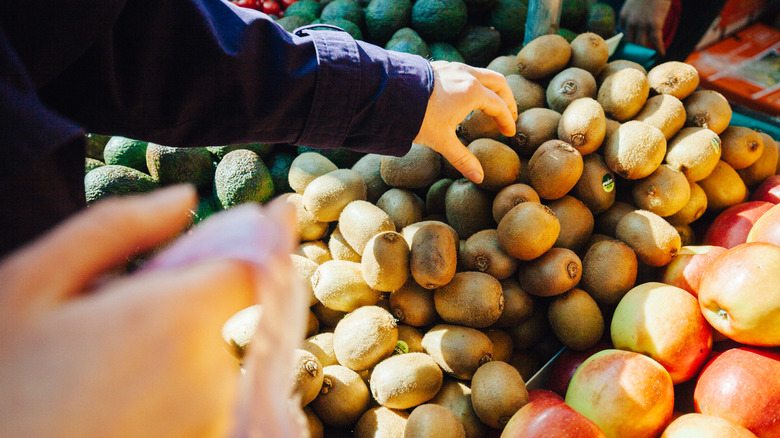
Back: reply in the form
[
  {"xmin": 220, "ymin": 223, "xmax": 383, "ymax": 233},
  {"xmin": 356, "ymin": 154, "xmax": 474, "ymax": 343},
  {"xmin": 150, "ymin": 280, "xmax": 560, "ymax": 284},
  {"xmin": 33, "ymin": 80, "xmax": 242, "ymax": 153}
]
[{"xmin": 610, "ymin": 282, "xmax": 712, "ymax": 385}]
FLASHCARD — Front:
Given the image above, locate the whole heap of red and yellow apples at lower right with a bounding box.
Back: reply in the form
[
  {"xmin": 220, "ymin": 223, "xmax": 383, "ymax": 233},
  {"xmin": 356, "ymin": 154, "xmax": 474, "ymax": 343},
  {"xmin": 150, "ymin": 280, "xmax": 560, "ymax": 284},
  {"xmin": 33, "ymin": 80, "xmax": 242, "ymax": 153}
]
[{"xmin": 508, "ymin": 179, "xmax": 780, "ymax": 438}]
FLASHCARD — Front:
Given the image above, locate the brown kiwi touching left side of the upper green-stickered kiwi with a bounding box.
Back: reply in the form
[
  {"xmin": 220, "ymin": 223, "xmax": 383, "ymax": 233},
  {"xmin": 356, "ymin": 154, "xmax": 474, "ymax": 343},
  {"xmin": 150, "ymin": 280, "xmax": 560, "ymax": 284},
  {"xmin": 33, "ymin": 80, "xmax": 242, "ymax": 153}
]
[{"xmin": 528, "ymin": 140, "xmax": 583, "ymax": 200}]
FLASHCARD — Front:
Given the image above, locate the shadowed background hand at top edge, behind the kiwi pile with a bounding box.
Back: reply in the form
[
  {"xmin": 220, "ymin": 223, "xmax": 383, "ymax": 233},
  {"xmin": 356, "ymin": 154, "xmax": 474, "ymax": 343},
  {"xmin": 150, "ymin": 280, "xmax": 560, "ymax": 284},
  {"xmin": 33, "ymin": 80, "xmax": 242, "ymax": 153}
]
[{"xmin": 618, "ymin": 0, "xmax": 672, "ymax": 56}]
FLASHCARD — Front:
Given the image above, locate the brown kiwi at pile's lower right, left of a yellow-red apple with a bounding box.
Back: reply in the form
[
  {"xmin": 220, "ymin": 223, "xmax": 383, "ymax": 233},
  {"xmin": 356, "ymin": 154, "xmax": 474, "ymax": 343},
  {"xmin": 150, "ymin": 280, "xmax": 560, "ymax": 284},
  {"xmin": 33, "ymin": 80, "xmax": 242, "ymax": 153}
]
[{"xmin": 547, "ymin": 288, "xmax": 604, "ymax": 351}]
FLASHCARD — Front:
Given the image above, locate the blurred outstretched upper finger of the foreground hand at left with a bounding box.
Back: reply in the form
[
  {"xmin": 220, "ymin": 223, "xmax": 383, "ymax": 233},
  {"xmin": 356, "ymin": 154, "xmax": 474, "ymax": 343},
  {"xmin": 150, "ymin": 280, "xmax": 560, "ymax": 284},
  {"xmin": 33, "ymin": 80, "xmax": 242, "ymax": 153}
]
[{"xmin": 0, "ymin": 185, "xmax": 196, "ymax": 305}]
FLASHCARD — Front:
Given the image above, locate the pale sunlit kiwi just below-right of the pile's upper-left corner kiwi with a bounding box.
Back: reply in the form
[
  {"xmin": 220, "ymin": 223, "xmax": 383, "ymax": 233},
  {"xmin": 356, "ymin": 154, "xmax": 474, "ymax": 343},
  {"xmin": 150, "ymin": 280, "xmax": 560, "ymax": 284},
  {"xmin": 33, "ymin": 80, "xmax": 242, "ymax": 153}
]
[{"xmin": 303, "ymin": 169, "xmax": 366, "ymax": 222}]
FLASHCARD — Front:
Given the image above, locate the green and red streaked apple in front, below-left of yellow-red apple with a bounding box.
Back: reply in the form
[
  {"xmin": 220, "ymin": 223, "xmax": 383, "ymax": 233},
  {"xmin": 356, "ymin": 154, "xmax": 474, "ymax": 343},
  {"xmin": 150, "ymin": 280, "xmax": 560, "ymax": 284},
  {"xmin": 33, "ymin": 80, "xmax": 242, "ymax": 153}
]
[{"xmin": 565, "ymin": 350, "xmax": 672, "ymax": 438}]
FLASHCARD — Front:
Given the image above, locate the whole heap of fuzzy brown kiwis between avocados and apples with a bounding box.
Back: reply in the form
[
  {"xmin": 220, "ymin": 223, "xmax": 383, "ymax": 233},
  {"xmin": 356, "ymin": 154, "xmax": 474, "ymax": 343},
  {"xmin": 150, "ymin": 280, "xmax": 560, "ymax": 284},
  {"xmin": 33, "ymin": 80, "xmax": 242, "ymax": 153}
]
[{"xmin": 215, "ymin": 33, "xmax": 778, "ymax": 438}]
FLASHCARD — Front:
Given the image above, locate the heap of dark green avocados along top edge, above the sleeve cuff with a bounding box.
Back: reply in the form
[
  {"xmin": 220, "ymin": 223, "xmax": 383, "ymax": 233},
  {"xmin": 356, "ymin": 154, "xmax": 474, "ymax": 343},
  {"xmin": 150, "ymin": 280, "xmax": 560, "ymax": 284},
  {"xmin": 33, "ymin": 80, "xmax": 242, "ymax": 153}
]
[{"xmin": 277, "ymin": 0, "xmax": 616, "ymax": 67}]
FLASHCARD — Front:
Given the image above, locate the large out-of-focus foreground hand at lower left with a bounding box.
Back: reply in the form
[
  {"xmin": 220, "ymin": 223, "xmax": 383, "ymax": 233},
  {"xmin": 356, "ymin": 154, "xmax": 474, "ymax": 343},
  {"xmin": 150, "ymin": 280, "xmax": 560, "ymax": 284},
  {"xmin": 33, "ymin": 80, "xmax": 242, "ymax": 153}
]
[{"xmin": 0, "ymin": 186, "xmax": 262, "ymax": 437}]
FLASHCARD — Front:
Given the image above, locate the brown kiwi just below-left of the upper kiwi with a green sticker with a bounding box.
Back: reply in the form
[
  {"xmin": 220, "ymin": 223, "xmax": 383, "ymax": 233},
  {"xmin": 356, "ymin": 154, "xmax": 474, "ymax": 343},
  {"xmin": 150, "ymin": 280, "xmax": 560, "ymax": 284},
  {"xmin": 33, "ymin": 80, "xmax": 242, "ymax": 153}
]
[{"xmin": 548, "ymin": 195, "xmax": 595, "ymax": 251}]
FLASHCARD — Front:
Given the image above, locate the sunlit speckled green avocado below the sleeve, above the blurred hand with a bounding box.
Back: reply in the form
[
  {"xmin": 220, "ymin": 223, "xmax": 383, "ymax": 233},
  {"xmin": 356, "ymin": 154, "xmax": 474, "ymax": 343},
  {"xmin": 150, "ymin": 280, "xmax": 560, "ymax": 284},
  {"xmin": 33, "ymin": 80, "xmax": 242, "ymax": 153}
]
[{"xmin": 214, "ymin": 149, "xmax": 274, "ymax": 208}]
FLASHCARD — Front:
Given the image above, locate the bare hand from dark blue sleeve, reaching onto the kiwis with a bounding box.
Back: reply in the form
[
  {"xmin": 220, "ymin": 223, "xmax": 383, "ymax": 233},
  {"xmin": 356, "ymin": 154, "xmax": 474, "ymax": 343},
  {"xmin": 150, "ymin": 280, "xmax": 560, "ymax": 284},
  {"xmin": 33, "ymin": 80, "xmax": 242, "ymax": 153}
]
[{"xmin": 414, "ymin": 61, "xmax": 517, "ymax": 183}]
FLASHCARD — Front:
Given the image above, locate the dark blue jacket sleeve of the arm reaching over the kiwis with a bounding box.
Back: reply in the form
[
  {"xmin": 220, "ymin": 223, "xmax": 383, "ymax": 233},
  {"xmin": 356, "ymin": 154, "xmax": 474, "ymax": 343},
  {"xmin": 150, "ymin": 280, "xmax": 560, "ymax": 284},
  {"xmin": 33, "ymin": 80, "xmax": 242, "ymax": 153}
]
[{"xmin": 2, "ymin": 0, "xmax": 433, "ymax": 155}]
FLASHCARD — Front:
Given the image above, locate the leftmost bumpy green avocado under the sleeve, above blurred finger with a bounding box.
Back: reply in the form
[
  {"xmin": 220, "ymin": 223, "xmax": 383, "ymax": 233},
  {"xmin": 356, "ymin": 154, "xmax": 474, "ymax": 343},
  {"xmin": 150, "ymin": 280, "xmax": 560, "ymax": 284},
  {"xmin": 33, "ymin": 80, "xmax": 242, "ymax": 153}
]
[{"xmin": 84, "ymin": 164, "xmax": 159, "ymax": 203}]
